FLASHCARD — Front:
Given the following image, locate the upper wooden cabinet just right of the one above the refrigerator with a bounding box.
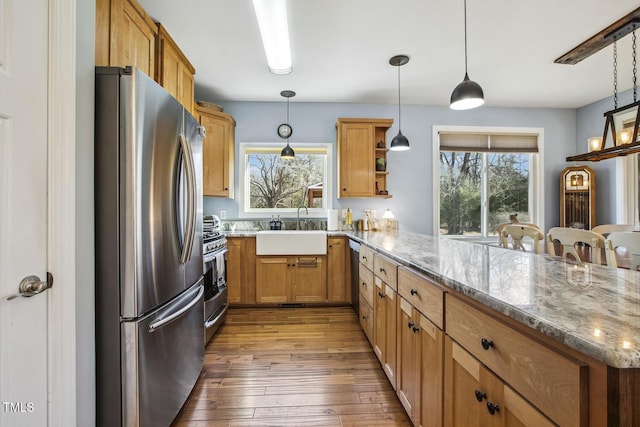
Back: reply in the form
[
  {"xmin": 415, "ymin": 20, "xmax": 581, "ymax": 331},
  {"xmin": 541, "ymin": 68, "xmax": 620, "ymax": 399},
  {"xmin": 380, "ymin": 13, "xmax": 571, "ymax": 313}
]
[{"xmin": 156, "ymin": 24, "xmax": 196, "ymax": 116}]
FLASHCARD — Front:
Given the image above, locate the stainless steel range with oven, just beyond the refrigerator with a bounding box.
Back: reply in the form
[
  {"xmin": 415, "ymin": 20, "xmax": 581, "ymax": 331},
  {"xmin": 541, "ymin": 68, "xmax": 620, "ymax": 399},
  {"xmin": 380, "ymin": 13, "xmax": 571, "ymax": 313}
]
[{"xmin": 202, "ymin": 215, "xmax": 229, "ymax": 345}]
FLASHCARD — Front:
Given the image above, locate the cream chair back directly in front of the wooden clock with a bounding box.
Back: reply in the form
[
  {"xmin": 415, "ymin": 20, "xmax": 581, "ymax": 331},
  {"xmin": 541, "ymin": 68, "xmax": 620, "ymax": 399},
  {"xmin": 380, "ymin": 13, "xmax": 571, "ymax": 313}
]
[{"xmin": 547, "ymin": 227, "xmax": 604, "ymax": 264}]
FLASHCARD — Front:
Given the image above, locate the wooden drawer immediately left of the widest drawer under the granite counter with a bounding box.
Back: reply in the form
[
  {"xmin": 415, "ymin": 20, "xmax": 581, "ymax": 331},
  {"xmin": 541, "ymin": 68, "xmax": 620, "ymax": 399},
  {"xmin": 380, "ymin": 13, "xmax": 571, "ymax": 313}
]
[{"xmin": 398, "ymin": 267, "xmax": 444, "ymax": 329}]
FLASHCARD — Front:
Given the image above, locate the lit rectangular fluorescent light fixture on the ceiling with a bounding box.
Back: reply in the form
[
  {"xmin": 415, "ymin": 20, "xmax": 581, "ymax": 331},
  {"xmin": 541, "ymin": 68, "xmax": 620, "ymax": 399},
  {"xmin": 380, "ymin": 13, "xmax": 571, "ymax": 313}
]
[{"xmin": 253, "ymin": 0, "xmax": 293, "ymax": 74}]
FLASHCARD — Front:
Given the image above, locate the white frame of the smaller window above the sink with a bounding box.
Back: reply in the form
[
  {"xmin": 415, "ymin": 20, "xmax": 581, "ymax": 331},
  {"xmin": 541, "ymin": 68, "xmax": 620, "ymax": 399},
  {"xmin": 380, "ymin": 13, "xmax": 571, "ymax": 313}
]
[{"xmin": 238, "ymin": 142, "xmax": 334, "ymax": 218}]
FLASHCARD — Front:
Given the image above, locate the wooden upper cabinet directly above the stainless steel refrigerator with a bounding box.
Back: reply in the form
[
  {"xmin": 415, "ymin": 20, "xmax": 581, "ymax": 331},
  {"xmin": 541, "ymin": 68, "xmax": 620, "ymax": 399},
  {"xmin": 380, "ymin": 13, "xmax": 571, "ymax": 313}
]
[{"xmin": 96, "ymin": 0, "xmax": 158, "ymax": 78}]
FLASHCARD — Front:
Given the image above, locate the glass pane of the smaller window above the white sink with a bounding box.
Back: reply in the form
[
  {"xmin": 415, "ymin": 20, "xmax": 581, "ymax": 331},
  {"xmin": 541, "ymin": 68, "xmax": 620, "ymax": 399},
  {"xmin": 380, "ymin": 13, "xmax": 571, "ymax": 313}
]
[{"xmin": 247, "ymin": 152, "xmax": 327, "ymax": 210}]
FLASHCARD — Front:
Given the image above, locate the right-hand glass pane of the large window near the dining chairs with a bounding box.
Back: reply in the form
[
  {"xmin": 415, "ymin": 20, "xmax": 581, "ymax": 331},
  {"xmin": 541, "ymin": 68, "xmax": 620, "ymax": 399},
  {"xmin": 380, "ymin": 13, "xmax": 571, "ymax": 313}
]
[{"xmin": 487, "ymin": 153, "xmax": 530, "ymax": 235}]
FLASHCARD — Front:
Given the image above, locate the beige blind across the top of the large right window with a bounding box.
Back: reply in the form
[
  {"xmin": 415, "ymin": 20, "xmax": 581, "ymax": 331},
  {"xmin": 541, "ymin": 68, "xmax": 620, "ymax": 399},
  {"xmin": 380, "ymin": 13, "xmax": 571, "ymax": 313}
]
[{"xmin": 439, "ymin": 132, "xmax": 538, "ymax": 153}]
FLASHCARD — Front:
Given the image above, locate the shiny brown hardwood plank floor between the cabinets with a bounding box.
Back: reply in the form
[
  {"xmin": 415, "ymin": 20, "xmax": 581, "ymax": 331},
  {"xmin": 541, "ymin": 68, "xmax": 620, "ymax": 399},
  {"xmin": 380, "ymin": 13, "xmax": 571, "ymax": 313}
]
[{"xmin": 172, "ymin": 307, "xmax": 411, "ymax": 427}]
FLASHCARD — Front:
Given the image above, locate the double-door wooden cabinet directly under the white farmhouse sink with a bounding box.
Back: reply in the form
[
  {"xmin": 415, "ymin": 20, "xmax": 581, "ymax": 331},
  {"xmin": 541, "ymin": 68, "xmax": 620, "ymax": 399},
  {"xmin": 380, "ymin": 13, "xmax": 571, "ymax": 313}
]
[{"xmin": 256, "ymin": 256, "xmax": 327, "ymax": 304}]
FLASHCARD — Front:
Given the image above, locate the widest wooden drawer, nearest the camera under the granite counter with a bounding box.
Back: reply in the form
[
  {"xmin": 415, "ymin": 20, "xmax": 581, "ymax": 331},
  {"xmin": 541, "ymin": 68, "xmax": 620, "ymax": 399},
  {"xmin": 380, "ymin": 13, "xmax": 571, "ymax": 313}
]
[{"xmin": 446, "ymin": 294, "xmax": 588, "ymax": 426}]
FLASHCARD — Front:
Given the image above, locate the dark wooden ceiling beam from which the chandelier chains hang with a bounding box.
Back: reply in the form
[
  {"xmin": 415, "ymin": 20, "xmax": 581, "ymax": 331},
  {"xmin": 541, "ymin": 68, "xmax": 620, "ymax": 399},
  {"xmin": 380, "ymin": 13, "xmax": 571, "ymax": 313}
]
[{"xmin": 553, "ymin": 7, "xmax": 640, "ymax": 65}]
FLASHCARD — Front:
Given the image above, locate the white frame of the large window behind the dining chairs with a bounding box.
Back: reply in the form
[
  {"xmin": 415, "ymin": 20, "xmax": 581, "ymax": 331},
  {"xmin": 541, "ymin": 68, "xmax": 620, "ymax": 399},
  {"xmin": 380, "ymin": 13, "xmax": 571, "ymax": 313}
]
[{"xmin": 432, "ymin": 126, "xmax": 545, "ymax": 241}]
